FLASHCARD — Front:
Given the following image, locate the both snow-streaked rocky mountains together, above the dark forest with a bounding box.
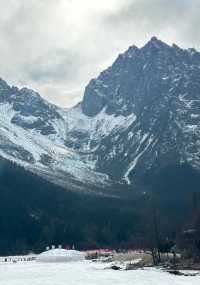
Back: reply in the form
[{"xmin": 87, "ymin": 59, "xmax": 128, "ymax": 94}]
[{"xmin": 0, "ymin": 37, "xmax": 200, "ymax": 189}]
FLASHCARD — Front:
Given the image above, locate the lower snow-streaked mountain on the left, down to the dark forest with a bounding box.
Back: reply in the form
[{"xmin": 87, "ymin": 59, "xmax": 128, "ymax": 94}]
[{"xmin": 0, "ymin": 77, "xmax": 110, "ymax": 191}]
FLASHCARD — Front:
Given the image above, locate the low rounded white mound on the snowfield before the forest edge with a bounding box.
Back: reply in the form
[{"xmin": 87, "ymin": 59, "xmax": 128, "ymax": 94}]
[{"xmin": 36, "ymin": 248, "xmax": 85, "ymax": 263}]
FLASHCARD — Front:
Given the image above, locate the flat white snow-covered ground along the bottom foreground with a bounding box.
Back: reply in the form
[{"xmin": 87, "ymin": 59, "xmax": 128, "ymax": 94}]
[{"xmin": 0, "ymin": 261, "xmax": 200, "ymax": 285}]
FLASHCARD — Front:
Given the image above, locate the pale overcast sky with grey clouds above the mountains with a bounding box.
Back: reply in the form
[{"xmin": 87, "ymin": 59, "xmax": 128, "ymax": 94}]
[{"xmin": 0, "ymin": 0, "xmax": 200, "ymax": 106}]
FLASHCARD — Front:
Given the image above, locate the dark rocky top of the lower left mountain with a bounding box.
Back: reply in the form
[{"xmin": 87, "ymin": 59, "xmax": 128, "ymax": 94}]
[{"xmin": 0, "ymin": 80, "xmax": 61, "ymax": 135}]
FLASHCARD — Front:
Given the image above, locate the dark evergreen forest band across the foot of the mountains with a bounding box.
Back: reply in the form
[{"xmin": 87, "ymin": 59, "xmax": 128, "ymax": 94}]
[{"xmin": 0, "ymin": 156, "xmax": 200, "ymax": 255}]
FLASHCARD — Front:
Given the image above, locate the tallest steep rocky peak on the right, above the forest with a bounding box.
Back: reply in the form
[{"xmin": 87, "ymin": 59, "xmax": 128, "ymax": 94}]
[{"xmin": 67, "ymin": 37, "xmax": 200, "ymax": 183}]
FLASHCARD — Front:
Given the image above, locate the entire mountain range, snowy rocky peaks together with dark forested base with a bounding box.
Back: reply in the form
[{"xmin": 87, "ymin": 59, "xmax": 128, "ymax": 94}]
[{"xmin": 0, "ymin": 37, "xmax": 200, "ymax": 253}]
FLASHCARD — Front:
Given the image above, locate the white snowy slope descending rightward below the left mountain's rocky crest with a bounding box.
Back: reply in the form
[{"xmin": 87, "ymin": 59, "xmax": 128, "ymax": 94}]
[{"xmin": 0, "ymin": 82, "xmax": 107, "ymax": 190}]
